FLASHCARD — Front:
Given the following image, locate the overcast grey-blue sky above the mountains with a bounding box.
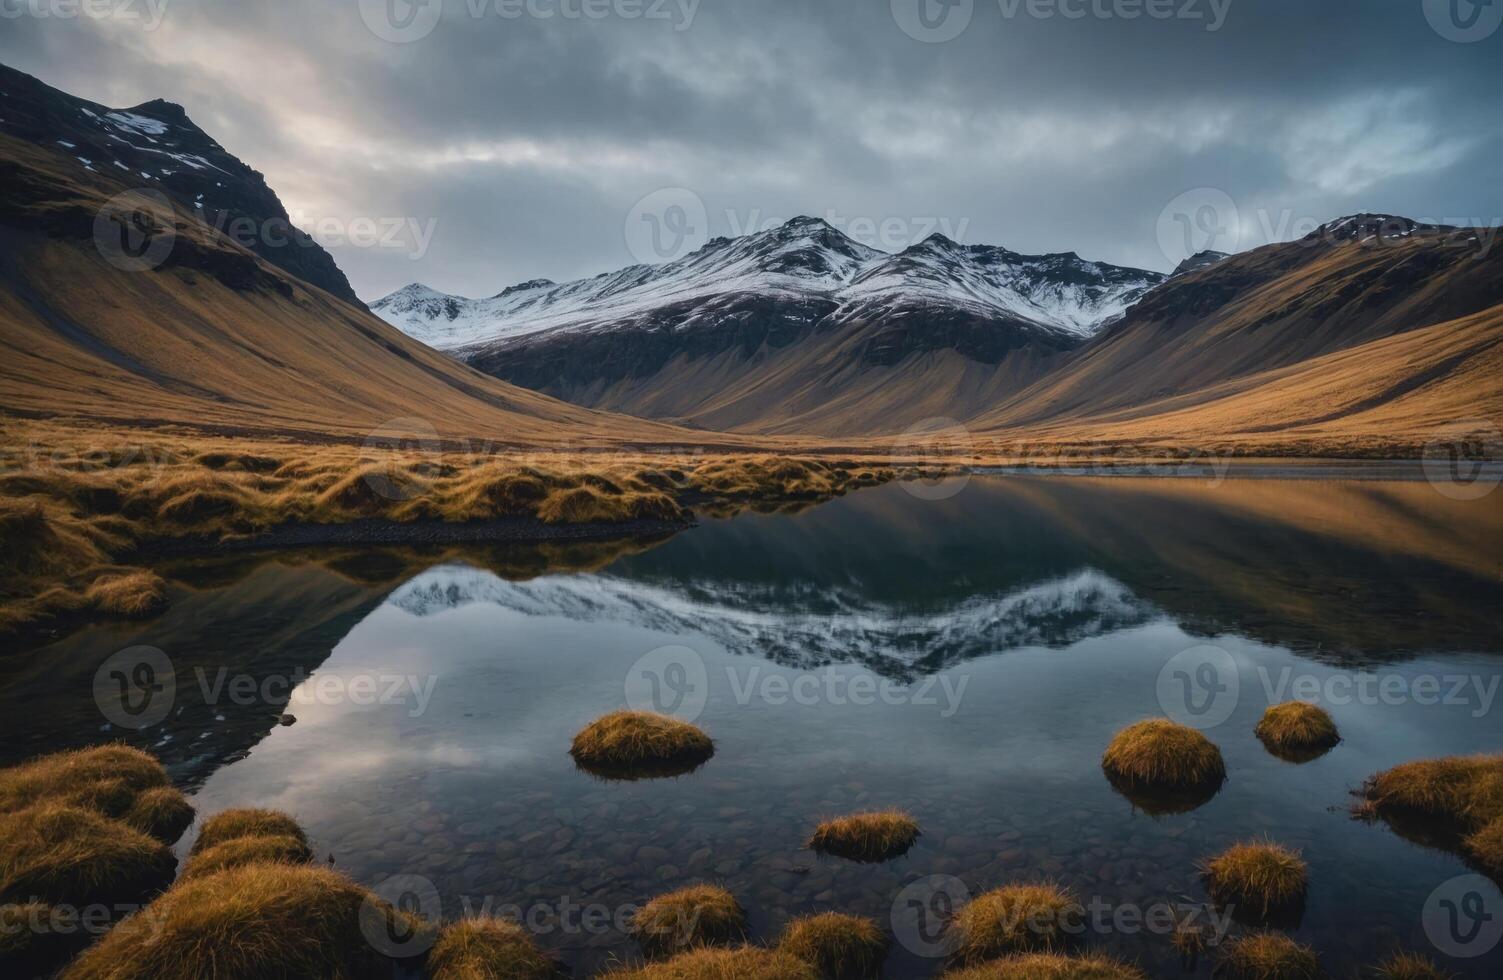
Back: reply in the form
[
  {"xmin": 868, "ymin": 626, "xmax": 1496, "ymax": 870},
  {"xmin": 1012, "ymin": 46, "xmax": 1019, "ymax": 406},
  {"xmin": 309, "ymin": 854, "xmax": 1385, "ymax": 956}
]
[{"xmin": 0, "ymin": 0, "xmax": 1503, "ymax": 301}]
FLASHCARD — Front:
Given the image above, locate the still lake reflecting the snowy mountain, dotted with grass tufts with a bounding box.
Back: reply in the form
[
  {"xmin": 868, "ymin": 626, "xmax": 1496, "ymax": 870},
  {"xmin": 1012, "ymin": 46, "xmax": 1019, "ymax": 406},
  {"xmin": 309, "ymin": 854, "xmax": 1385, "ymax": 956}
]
[{"xmin": 0, "ymin": 473, "xmax": 1503, "ymax": 977}]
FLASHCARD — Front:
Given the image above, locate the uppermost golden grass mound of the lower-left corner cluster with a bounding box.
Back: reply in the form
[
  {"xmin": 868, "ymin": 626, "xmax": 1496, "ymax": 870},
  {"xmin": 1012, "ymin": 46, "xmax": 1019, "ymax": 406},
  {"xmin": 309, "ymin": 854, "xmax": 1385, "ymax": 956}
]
[{"xmin": 0, "ymin": 746, "xmax": 192, "ymax": 843}]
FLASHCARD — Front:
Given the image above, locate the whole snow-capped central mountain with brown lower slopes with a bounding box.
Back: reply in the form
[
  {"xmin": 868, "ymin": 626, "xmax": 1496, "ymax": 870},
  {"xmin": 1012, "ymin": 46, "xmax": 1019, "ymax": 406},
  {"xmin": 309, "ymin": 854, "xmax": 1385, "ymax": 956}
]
[{"xmin": 371, "ymin": 218, "xmax": 1163, "ymax": 434}]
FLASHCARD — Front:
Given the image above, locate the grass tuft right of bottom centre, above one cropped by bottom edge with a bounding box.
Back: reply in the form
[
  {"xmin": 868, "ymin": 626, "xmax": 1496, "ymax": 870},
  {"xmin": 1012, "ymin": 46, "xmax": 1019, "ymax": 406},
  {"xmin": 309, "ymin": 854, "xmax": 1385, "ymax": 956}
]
[{"xmin": 951, "ymin": 882, "xmax": 1082, "ymax": 965}]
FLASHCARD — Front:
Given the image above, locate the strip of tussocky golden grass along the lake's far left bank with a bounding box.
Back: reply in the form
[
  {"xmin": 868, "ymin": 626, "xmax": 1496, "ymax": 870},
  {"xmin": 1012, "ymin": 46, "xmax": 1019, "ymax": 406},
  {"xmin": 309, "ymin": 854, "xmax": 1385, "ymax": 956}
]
[{"xmin": 0, "ymin": 421, "xmax": 897, "ymax": 633}]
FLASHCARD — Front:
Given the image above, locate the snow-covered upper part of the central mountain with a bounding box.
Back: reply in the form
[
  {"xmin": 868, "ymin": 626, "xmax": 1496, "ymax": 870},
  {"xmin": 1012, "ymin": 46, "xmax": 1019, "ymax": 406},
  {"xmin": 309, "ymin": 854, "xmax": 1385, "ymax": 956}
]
[{"xmin": 371, "ymin": 218, "xmax": 1163, "ymax": 350}]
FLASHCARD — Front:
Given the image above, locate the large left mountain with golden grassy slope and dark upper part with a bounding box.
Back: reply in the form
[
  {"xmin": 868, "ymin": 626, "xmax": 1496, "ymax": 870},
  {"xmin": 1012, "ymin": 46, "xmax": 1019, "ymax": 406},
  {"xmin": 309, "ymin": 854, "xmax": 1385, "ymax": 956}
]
[{"xmin": 0, "ymin": 72, "xmax": 702, "ymax": 446}]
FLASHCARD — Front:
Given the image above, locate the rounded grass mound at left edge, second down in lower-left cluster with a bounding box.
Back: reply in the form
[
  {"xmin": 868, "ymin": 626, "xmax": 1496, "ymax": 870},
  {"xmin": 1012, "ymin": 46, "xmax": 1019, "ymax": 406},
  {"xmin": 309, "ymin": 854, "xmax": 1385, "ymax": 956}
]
[{"xmin": 0, "ymin": 803, "xmax": 177, "ymax": 906}]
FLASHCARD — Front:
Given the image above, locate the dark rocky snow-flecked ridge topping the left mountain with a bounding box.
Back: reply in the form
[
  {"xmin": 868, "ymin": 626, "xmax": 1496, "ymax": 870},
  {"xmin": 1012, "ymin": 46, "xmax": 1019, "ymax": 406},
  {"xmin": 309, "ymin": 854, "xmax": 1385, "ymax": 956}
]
[{"xmin": 0, "ymin": 65, "xmax": 361, "ymax": 305}]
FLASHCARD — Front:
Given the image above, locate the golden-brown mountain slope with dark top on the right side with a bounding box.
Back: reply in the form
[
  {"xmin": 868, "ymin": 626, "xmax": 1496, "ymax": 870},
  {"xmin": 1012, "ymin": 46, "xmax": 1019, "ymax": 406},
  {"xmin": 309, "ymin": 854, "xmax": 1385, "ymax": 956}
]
[{"xmin": 969, "ymin": 215, "xmax": 1503, "ymax": 452}]
